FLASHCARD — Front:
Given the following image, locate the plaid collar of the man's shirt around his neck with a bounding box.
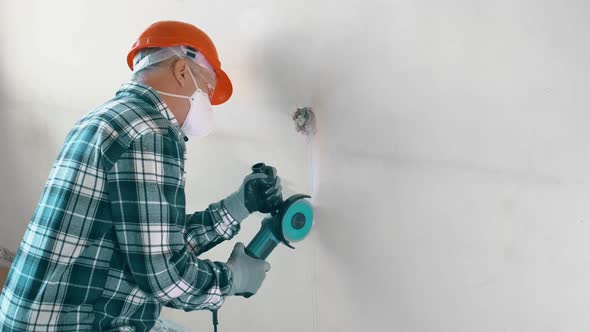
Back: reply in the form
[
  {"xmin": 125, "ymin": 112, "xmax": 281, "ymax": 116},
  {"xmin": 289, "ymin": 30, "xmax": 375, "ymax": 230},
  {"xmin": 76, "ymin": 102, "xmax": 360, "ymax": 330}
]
[{"xmin": 116, "ymin": 81, "xmax": 188, "ymax": 142}]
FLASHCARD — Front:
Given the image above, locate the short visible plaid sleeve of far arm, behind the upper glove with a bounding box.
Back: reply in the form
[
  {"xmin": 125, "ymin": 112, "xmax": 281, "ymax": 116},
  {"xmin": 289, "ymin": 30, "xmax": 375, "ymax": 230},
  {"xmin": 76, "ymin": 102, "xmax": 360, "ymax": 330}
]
[{"xmin": 186, "ymin": 201, "xmax": 240, "ymax": 255}]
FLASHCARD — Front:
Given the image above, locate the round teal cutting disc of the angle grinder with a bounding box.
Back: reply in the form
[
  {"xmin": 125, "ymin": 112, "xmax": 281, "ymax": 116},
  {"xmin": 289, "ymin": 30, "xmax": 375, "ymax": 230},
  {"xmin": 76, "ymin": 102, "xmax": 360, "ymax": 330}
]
[{"xmin": 279, "ymin": 195, "xmax": 313, "ymax": 245}]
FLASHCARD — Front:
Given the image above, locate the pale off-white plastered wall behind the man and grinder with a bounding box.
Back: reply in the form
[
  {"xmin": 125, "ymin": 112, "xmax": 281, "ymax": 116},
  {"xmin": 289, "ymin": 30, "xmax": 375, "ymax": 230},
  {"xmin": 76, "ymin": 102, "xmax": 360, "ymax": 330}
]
[{"xmin": 0, "ymin": 0, "xmax": 590, "ymax": 332}]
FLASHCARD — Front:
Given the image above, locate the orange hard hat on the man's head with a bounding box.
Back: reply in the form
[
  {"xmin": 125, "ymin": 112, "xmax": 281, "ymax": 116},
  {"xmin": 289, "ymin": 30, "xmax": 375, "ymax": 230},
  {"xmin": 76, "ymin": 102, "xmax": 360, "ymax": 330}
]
[{"xmin": 127, "ymin": 21, "xmax": 233, "ymax": 105}]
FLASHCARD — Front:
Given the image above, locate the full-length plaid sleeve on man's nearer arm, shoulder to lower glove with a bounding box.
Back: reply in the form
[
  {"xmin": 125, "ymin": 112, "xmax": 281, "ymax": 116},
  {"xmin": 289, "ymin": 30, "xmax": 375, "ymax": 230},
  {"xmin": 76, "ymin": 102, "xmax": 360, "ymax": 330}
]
[{"xmin": 107, "ymin": 133, "xmax": 232, "ymax": 311}]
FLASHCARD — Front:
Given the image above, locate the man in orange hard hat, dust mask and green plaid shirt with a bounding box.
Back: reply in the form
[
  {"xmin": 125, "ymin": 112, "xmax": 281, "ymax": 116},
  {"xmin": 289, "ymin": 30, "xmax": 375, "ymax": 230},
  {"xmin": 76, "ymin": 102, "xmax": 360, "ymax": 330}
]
[{"xmin": 0, "ymin": 21, "xmax": 282, "ymax": 331}]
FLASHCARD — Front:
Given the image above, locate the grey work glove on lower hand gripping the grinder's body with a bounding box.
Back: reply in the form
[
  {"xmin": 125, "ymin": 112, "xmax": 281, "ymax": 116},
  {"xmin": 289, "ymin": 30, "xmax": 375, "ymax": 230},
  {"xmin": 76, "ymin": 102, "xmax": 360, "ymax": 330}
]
[{"xmin": 226, "ymin": 242, "xmax": 270, "ymax": 297}]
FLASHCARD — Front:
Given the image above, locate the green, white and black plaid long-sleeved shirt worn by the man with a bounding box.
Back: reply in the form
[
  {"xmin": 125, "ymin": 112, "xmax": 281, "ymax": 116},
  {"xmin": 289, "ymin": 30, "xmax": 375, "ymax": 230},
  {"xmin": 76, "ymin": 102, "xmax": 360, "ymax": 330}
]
[{"xmin": 0, "ymin": 82, "xmax": 241, "ymax": 331}]
